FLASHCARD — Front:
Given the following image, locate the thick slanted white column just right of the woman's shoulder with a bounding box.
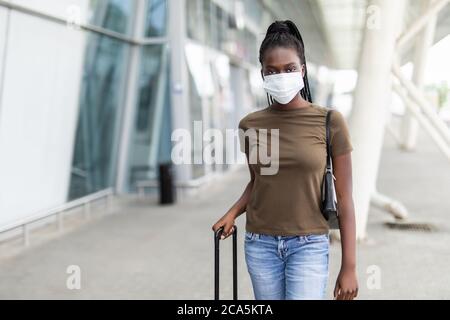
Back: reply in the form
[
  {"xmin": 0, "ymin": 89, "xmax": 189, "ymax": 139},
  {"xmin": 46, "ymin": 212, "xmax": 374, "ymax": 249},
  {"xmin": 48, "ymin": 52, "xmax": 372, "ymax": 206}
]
[{"xmin": 349, "ymin": 0, "xmax": 405, "ymax": 239}]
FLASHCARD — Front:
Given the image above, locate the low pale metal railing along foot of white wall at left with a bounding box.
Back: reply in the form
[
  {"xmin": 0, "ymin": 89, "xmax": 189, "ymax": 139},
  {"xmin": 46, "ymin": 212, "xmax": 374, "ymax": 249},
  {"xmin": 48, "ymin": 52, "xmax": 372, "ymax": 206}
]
[{"xmin": 0, "ymin": 188, "xmax": 114, "ymax": 246}]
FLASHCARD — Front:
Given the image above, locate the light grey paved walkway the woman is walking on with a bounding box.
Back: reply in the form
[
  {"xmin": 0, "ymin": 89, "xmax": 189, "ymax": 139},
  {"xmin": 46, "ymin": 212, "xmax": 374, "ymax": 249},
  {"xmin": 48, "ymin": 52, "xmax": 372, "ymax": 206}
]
[{"xmin": 0, "ymin": 125, "xmax": 450, "ymax": 299}]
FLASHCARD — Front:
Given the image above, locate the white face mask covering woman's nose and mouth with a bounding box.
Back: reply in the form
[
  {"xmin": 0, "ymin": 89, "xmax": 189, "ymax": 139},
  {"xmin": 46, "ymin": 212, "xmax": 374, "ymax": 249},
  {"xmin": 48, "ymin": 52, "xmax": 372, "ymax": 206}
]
[{"xmin": 264, "ymin": 72, "xmax": 305, "ymax": 104}]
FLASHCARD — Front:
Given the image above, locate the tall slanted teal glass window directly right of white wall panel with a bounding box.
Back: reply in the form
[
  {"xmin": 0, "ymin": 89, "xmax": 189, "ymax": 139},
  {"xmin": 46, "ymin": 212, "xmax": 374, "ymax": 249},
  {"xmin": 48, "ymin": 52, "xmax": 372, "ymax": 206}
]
[{"xmin": 69, "ymin": 34, "xmax": 128, "ymax": 200}]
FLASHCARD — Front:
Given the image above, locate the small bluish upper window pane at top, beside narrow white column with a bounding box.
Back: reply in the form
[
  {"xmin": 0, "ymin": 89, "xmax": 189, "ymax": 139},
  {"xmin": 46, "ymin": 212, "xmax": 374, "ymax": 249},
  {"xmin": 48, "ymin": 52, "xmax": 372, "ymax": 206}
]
[{"xmin": 145, "ymin": 0, "xmax": 167, "ymax": 37}]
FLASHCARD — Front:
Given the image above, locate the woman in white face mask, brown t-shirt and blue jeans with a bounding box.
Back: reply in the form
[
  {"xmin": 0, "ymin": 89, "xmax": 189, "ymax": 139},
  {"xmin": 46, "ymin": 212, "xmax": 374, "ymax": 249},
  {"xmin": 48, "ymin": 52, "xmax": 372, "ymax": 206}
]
[{"xmin": 212, "ymin": 20, "xmax": 358, "ymax": 300}]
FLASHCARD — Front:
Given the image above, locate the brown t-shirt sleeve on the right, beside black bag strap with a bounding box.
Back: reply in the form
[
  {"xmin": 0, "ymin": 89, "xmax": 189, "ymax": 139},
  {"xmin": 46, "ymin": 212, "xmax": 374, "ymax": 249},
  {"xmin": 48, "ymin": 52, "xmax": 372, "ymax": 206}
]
[{"xmin": 330, "ymin": 110, "xmax": 353, "ymax": 156}]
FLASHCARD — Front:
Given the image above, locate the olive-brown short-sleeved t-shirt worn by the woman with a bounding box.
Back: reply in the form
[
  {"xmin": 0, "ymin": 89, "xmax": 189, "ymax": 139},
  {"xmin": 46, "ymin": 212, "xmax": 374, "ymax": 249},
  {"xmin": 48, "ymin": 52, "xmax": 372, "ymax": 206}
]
[{"xmin": 239, "ymin": 104, "xmax": 353, "ymax": 235}]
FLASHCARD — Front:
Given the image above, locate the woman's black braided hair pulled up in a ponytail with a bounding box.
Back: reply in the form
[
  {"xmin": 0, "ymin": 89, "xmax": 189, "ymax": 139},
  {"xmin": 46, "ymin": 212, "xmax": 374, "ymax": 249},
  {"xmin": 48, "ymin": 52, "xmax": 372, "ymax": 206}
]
[{"xmin": 259, "ymin": 20, "xmax": 312, "ymax": 104}]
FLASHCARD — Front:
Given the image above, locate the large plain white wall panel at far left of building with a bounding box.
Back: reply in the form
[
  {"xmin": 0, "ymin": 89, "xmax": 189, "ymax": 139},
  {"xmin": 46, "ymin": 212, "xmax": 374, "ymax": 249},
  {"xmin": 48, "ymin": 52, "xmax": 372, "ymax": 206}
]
[{"xmin": 0, "ymin": 1, "xmax": 86, "ymax": 225}]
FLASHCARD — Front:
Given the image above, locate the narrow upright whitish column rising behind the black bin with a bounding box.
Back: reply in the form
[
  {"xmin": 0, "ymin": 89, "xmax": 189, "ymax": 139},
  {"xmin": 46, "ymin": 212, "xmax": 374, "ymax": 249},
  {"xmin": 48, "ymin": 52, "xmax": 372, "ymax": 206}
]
[{"xmin": 169, "ymin": 0, "xmax": 192, "ymax": 181}]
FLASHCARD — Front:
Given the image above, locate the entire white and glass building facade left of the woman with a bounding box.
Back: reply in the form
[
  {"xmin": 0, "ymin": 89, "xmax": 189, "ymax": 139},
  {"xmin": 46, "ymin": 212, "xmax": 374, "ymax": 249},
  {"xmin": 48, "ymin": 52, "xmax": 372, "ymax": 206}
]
[{"xmin": 0, "ymin": 0, "xmax": 270, "ymax": 229}]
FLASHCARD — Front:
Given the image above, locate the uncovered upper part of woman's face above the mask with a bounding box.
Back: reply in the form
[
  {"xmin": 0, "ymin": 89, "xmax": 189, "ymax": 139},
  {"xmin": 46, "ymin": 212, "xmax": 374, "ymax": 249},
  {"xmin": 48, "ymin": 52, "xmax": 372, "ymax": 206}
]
[{"xmin": 261, "ymin": 47, "xmax": 304, "ymax": 78}]
